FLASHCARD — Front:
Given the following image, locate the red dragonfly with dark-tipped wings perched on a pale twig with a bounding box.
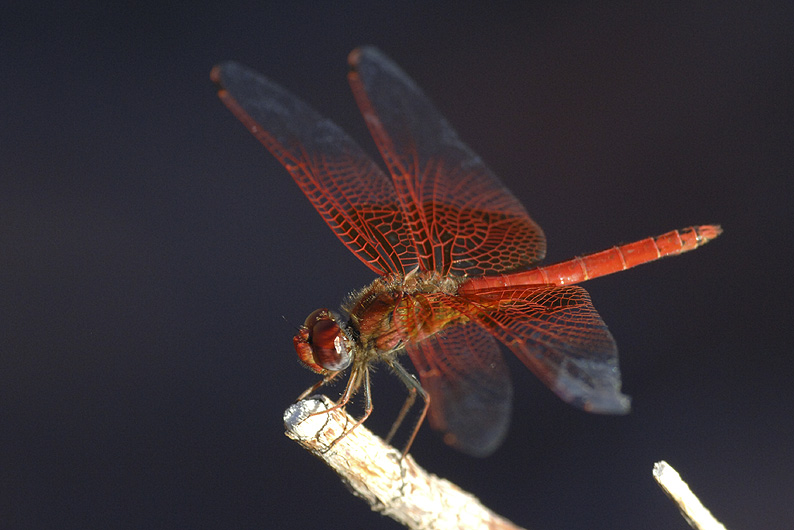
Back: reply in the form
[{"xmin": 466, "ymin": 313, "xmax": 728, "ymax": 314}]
[{"xmin": 211, "ymin": 47, "xmax": 721, "ymax": 456}]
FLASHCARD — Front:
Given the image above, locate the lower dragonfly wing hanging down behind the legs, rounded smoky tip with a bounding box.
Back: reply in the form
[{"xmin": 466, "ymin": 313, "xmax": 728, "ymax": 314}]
[{"xmin": 405, "ymin": 322, "xmax": 513, "ymax": 457}]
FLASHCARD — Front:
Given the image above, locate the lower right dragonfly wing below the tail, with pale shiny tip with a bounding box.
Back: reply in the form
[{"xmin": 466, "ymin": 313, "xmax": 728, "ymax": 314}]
[{"xmin": 458, "ymin": 285, "xmax": 630, "ymax": 414}]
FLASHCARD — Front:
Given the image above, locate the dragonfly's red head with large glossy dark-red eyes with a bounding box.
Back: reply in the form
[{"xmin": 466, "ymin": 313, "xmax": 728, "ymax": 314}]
[{"xmin": 293, "ymin": 309, "xmax": 353, "ymax": 374}]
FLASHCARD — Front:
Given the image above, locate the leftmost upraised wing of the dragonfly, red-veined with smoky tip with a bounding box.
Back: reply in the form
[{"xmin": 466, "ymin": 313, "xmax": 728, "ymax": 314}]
[{"xmin": 211, "ymin": 62, "xmax": 417, "ymax": 274}]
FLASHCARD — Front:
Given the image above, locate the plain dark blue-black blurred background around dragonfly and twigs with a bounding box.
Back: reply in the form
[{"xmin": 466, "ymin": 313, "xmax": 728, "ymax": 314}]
[{"xmin": 0, "ymin": 1, "xmax": 794, "ymax": 530}]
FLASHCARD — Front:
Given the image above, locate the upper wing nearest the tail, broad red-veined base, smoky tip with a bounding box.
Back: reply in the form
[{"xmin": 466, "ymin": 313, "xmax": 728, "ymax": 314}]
[{"xmin": 348, "ymin": 47, "xmax": 546, "ymax": 276}]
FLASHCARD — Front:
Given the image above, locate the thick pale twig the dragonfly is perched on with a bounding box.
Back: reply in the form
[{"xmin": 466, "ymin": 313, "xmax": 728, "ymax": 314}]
[{"xmin": 284, "ymin": 396, "xmax": 521, "ymax": 530}]
